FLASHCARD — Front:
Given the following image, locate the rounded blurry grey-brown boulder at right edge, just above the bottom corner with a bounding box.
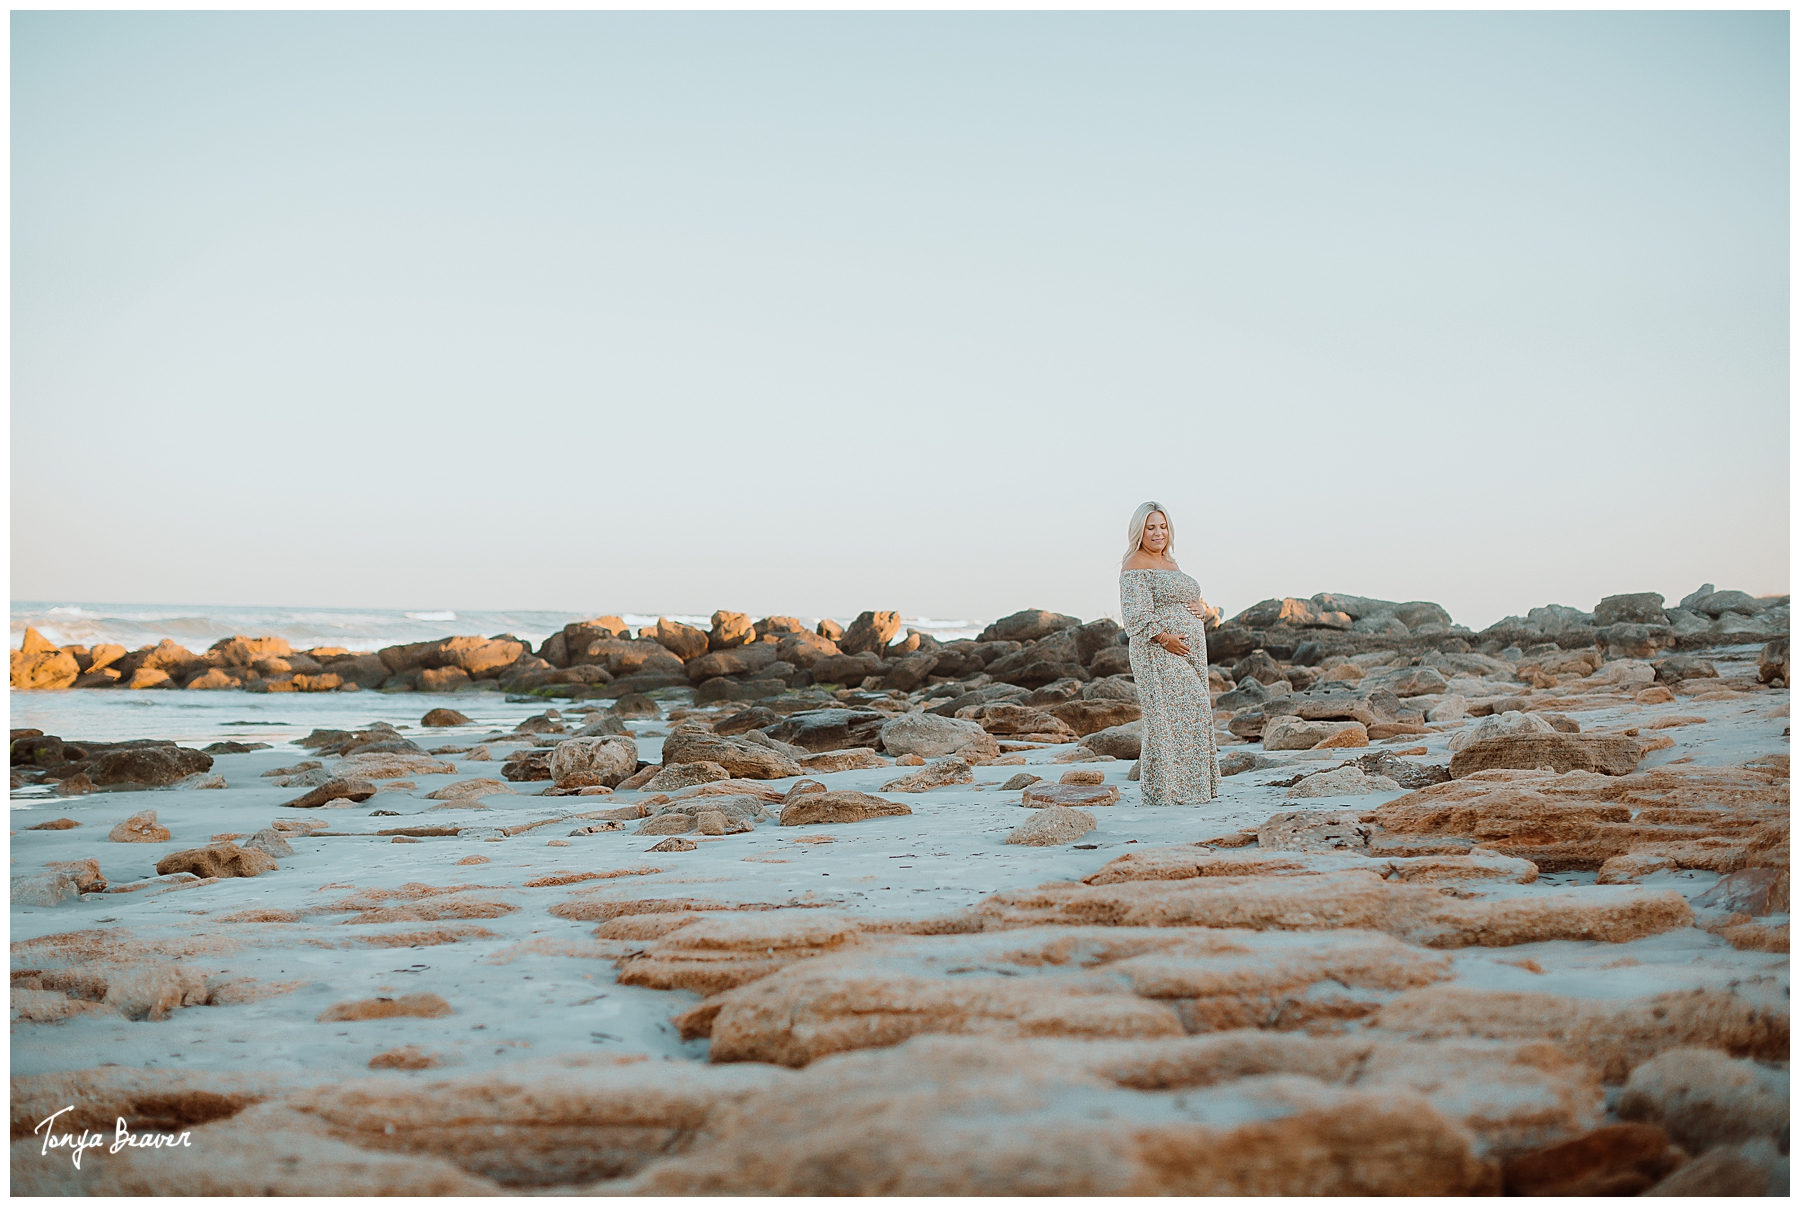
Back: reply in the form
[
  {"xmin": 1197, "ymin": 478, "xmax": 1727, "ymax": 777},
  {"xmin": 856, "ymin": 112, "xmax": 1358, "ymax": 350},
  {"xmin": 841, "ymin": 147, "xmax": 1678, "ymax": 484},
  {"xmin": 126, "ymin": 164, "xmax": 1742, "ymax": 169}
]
[{"xmin": 1618, "ymin": 1047, "xmax": 1787, "ymax": 1157}]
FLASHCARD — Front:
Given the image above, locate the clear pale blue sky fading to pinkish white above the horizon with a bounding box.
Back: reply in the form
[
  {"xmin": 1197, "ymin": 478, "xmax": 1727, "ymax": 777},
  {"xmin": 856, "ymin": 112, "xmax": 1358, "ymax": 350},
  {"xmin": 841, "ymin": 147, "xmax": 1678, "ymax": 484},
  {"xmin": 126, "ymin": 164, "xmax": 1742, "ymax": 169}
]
[{"xmin": 11, "ymin": 13, "xmax": 1789, "ymax": 628}]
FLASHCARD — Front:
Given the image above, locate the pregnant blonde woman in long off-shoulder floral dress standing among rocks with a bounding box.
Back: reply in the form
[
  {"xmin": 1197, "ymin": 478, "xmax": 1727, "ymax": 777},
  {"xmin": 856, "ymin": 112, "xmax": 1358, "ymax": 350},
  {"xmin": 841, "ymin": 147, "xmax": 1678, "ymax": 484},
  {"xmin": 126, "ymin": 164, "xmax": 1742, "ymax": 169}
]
[{"xmin": 1120, "ymin": 502, "xmax": 1219, "ymax": 804}]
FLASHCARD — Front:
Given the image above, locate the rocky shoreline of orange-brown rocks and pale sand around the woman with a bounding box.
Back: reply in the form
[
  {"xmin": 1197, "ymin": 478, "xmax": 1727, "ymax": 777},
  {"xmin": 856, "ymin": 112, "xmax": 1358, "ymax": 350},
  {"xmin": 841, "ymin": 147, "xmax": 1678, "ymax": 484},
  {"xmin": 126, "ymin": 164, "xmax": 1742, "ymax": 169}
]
[{"xmin": 13, "ymin": 586, "xmax": 1789, "ymax": 1194}]
